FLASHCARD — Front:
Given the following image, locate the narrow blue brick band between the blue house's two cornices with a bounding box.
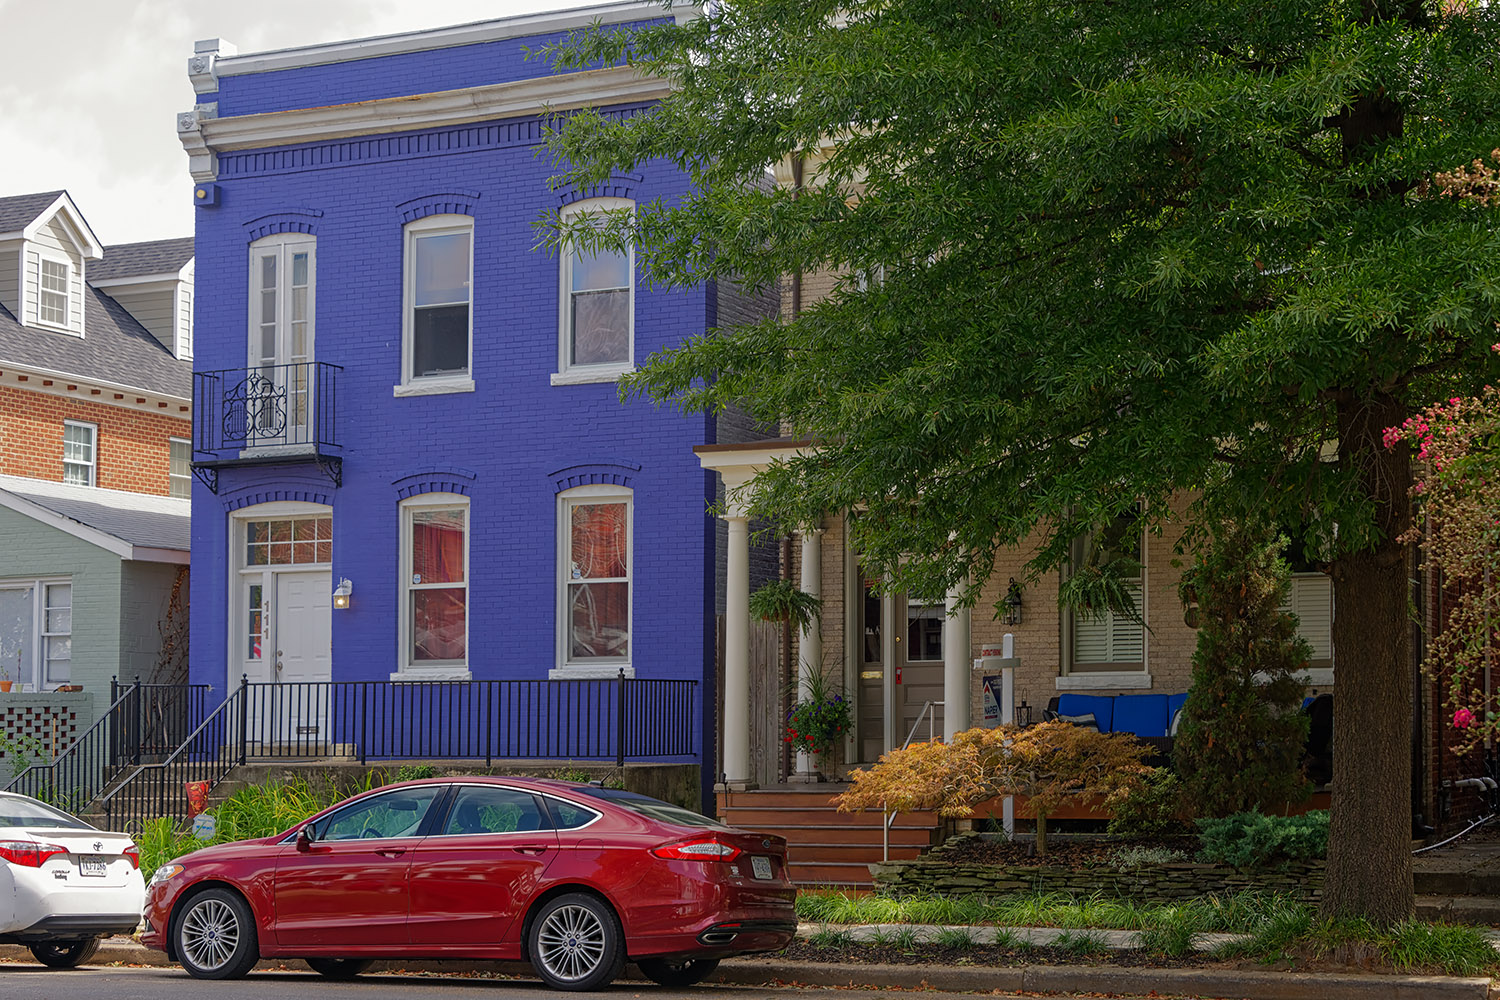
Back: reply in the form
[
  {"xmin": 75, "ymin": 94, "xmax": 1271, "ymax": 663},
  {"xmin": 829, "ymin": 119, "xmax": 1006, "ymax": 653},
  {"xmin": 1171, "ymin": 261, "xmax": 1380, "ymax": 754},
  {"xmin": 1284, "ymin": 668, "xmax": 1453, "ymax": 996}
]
[{"xmin": 217, "ymin": 18, "xmax": 660, "ymax": 117}]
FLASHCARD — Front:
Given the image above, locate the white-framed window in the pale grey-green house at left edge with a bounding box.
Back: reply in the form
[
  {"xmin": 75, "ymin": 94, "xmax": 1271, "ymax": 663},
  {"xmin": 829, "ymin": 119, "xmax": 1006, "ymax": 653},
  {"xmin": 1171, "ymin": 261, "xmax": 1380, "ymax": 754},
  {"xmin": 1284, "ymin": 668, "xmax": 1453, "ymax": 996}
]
[{"xmin": 0, "ymin": 579, "xmax": 74, "ymax": 691}]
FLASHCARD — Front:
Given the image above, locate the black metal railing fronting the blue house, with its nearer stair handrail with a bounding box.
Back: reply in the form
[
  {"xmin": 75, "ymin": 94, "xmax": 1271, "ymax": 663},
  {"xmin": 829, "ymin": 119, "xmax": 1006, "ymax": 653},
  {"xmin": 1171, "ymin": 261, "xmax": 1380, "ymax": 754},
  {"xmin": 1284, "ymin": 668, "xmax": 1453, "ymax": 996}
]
[{"xmin": 99, "ymin": 672, "xmax": 699, "ymax": 820}]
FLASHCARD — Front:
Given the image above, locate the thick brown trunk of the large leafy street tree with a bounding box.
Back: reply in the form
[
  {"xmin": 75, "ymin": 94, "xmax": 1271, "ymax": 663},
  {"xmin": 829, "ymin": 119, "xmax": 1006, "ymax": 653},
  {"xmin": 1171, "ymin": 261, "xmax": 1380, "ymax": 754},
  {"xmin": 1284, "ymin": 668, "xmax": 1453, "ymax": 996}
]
[{"xmin": 1322, "ymin": 394, "xmax": 1413, "ymax": 925}]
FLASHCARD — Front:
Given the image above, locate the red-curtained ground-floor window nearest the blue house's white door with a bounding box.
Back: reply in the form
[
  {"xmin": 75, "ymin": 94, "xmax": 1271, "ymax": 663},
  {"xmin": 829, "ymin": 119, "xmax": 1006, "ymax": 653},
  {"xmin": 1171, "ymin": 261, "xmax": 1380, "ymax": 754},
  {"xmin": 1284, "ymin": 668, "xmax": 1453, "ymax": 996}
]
[{"xmin": 399, "ymin": 493, "xmax": 468, "ymax": 672}]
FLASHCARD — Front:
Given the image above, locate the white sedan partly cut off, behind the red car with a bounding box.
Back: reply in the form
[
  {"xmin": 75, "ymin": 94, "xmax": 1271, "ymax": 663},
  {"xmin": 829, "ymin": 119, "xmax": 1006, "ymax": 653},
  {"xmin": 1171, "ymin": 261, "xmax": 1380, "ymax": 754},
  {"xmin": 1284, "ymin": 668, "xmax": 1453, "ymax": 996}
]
[{"xmin": 0, "ymin": 792, "xmax": 146, "ymax": 969}]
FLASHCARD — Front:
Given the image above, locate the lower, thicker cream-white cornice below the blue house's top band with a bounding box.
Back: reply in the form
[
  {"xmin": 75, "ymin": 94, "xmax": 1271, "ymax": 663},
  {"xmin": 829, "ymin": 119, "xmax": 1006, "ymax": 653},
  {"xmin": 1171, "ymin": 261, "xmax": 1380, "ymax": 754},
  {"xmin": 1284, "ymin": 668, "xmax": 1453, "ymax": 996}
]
[{"xmin": 199, "ymin": 66, "xmax": 671, "ymax": 156}]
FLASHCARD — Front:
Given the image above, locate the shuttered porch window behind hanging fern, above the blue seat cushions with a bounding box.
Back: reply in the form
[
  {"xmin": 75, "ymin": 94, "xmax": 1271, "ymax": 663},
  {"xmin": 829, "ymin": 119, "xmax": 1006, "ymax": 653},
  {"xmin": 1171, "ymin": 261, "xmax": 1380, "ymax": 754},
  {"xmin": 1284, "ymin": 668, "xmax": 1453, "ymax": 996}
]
[{"xmin": 1068, "ymin": 510, "xmax": 1146, "ymax": 672}]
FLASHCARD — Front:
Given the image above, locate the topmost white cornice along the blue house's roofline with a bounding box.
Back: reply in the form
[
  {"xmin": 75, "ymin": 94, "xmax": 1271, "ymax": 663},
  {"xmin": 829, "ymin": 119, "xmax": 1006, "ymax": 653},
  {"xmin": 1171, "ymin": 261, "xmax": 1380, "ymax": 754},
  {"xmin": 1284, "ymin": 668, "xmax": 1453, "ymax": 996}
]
[{"xmin": 211, "ymin": 0, "xmax": 699, "ymax": 78}]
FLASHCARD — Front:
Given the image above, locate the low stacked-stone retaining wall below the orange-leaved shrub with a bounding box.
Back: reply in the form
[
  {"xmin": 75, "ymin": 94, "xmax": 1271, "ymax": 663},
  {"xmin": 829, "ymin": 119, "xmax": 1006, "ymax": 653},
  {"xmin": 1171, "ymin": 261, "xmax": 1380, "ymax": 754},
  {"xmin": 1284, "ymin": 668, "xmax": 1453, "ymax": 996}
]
[{"xmin": 870, "ymin": 847, "xmax": 1323, "ymax": 903}]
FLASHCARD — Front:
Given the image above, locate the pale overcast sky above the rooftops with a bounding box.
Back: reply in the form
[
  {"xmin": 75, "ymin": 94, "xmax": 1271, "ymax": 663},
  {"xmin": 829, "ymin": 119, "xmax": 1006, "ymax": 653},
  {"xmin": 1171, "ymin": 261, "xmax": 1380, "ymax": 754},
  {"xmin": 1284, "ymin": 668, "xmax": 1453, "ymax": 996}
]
[{"xmin": 0, "ymin": 0, "xmax": 582, "ymax": 244}]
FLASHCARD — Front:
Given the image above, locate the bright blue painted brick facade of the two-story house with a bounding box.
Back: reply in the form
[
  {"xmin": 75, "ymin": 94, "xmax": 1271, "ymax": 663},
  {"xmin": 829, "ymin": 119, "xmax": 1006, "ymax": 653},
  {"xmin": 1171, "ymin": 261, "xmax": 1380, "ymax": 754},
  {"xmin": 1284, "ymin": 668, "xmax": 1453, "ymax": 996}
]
[{"xmin": 192, "ymin": 42, "xmax": 726, "ymax": 791}]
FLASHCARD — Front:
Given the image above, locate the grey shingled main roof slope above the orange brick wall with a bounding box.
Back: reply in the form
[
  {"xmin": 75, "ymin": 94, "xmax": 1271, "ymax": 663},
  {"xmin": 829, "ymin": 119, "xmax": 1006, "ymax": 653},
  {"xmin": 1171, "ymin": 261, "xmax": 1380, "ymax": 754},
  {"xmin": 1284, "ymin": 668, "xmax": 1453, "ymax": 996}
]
[{"xmin": 0, "ymin": 288, "xmax": 192, "ymax": 395}]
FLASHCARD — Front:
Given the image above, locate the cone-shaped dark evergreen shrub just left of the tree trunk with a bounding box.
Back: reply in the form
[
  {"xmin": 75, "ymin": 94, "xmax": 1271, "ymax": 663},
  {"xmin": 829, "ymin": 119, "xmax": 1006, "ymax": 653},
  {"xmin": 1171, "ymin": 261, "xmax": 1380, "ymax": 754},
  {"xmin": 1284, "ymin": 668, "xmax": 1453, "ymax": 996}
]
[{"xmin": 1172, "ymin": 522, "xmax": 1313, "ymax": 817}]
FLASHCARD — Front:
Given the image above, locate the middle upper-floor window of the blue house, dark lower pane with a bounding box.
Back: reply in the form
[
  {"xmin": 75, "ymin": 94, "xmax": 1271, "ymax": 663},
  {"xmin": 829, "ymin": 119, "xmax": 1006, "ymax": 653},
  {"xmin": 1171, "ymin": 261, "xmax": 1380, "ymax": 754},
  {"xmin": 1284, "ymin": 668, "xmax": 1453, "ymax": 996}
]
[{"xmin": 402, "ymin": 214, "xmax": 474, "ymax": 391}]
